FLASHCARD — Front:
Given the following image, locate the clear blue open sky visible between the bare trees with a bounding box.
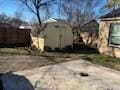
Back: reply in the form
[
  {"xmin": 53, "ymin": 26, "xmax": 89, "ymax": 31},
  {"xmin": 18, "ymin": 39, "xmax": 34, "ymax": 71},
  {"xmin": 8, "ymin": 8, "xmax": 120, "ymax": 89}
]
[{"xmin": 0, "ymin": 0, "xmax": 106, "ymax": 21}]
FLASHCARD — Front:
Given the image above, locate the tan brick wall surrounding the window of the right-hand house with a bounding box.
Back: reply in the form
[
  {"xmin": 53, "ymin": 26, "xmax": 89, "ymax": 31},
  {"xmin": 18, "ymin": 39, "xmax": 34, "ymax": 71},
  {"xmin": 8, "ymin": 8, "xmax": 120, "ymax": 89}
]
[{"xmin": 98, "ymin": 20, "xmax": 120, "ymax": 58}]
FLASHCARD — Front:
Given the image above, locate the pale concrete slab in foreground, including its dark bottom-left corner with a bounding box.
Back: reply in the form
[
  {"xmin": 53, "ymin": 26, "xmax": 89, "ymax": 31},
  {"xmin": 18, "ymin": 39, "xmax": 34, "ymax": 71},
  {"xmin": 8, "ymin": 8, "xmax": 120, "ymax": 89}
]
[{"xmin": 2, "ymin": 60, "xmax": 120, "ymax": 90}]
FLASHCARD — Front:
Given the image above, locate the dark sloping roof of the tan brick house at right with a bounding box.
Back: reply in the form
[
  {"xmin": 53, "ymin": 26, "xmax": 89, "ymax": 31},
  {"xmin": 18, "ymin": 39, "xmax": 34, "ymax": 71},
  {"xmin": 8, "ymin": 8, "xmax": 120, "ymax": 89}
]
[{"xmin": 100, "ymin": 8, "xmax": 120, "ymax": 18}]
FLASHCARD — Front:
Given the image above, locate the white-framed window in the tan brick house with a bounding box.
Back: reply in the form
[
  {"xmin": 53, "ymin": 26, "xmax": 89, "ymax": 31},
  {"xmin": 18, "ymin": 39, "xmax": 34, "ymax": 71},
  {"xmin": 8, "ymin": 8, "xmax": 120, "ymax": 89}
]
[{"xmin": 109, "ymin": 23, "xmax": 120, "ymax": 47}]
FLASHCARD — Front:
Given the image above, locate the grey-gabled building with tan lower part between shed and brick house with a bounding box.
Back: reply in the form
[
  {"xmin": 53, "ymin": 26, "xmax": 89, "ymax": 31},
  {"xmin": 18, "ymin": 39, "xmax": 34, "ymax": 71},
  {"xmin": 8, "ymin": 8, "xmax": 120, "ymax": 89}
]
[{"xmin": 80, "ymin": 21, "xmax": 99, "ymax": 48}]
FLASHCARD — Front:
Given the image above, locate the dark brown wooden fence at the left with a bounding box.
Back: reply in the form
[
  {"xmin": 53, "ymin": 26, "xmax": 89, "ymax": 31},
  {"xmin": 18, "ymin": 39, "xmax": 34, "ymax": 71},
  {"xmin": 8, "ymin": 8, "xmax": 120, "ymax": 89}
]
[{"xmin": 0, "ymin": 27, "xmax": 31, "ymax": 47}]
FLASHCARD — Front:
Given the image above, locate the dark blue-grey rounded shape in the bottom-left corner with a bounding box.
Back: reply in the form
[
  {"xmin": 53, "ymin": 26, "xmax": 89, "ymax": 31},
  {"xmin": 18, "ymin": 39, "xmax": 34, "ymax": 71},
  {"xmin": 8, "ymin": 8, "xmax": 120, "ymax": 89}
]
[{"xmin": 0, "ymin": 73, "xmax": 34, "ymax": 90}]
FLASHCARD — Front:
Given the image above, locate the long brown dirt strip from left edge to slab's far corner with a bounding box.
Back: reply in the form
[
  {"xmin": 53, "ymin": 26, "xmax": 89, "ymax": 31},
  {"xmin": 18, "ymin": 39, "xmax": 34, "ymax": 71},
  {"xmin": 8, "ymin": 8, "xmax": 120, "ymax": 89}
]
[{"xmin": 0, "ymin": 53, "xmax": 80, "ymax": 73}]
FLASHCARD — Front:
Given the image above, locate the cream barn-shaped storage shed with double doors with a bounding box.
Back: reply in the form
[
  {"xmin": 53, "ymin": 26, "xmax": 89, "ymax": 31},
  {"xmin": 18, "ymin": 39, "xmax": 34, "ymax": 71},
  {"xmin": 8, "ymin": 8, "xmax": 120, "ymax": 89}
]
[{"xmin": 43, "ymin": 22, "xmax": 73, "ymax": 50}]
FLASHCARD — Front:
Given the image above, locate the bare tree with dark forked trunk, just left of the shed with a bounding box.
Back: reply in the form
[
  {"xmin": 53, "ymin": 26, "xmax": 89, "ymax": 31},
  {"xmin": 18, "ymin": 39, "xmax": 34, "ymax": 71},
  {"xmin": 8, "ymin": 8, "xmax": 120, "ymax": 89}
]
[{"xmin": 19, "ymin": 0, "xmax": 56, "ymax": 48}]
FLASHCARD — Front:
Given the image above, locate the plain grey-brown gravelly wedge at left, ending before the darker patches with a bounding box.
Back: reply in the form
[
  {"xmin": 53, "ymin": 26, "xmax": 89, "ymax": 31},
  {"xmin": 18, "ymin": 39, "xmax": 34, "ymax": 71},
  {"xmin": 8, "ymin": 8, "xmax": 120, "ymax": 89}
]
[{"xmin": 0, "ymin": 55, "xmax": 54, "ymax": 73}]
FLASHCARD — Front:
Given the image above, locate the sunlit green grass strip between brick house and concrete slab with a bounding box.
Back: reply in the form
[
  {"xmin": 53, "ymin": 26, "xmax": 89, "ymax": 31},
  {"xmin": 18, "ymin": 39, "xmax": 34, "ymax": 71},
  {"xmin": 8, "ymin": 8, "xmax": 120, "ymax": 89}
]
[{"xmin": 84, "ymin": 54, "xmax": 120, "ymax": 70}]
